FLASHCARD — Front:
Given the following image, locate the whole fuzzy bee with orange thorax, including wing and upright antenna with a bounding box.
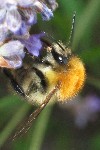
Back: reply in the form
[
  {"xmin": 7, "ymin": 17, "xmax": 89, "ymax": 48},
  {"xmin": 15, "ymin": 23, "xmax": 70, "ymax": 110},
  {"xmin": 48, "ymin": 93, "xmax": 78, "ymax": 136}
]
[{"xmin": 4, "ymin": 14, "xmax": 86, "ymax": 138}]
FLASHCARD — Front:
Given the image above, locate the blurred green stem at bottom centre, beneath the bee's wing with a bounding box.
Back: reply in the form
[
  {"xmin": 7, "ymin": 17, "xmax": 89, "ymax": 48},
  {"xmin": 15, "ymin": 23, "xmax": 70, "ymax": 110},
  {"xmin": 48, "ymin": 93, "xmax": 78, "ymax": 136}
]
[{"xmin": 29, "ymin": 106, "xmax": 52, "ymax": 150}]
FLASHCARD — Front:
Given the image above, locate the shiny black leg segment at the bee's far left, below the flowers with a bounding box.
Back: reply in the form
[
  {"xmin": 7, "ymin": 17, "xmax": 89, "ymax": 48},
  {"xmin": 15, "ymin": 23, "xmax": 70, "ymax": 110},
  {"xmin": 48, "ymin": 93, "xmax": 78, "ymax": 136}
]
[{"xmin": 3, "ymin": 69, "xmax": 26, "ymax": 97}]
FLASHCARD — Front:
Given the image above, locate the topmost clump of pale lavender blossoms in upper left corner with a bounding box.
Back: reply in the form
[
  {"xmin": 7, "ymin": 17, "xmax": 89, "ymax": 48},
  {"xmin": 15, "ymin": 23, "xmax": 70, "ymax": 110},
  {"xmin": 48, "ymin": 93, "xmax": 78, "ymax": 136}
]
[{"xmin": 0, "ymin": 0, "xmax": 53, "ymax": 33}]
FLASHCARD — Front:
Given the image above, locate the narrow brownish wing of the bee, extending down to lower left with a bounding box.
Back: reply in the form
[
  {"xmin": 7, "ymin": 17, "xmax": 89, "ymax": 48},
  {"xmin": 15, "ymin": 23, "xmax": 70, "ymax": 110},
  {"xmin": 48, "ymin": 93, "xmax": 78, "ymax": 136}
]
[{"xmin": 11, "ymin": 84, "xmax": 59, "ymax": 141}]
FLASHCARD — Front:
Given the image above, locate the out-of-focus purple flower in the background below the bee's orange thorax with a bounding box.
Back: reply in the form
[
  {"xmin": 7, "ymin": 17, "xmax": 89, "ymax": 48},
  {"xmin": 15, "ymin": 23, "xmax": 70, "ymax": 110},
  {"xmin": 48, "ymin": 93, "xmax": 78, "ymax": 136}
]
[{"xmin": 67, "ymin": 95, "xmax": 100, "ymax": 128}]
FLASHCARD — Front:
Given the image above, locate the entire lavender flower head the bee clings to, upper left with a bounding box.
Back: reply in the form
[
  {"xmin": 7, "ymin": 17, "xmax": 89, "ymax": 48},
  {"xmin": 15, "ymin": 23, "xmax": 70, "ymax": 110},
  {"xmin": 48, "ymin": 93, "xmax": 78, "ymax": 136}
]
[{"xmin": 0, "ymin": 0, "xmax": 56, "ymax": 69}]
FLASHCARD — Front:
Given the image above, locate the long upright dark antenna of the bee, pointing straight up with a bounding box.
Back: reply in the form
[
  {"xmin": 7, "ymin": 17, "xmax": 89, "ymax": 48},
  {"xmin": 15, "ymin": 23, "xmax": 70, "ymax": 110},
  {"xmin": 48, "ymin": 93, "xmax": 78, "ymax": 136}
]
[{"xmin": 66, "ymin": 11, "xmax": 76, "ymax": 48}]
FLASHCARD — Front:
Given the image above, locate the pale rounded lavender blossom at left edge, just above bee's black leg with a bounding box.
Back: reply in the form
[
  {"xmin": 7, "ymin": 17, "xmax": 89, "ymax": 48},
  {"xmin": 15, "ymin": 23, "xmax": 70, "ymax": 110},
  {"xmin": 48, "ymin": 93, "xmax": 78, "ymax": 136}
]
[{"xmin": 0, "ymin": 40, "xmax": 25, "ymax": 69}]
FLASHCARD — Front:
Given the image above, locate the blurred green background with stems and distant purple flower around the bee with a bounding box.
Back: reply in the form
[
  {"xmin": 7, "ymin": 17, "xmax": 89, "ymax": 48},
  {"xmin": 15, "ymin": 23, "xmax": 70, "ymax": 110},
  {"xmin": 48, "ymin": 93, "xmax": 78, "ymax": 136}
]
[{"xmin": 0, "ymin": 0, "xmax": 100, "ymax": 150}]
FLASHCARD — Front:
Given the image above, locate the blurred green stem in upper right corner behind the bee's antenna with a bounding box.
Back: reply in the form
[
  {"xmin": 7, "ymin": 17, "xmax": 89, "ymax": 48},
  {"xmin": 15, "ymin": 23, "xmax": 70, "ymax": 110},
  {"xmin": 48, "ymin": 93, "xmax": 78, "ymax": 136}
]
[{"xmin": 73, "ymin": 0, "xmax": 100, "ymax": 50}]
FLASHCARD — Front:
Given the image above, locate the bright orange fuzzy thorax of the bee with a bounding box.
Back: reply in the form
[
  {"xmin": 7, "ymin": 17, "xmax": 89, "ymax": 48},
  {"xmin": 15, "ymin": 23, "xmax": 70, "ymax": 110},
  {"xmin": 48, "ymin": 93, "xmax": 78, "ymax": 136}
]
[{"xmin": 58, "ymin": 56, "xmax": 85, "ymax": 101}]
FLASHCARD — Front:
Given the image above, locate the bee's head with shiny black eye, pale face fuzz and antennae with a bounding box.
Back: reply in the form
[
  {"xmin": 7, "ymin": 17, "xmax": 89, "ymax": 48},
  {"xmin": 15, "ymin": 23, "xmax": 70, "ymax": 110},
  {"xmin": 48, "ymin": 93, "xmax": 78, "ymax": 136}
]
[{"xmin": 47, "ymin": 12, "xmax": 76, "ymax": 65}]
